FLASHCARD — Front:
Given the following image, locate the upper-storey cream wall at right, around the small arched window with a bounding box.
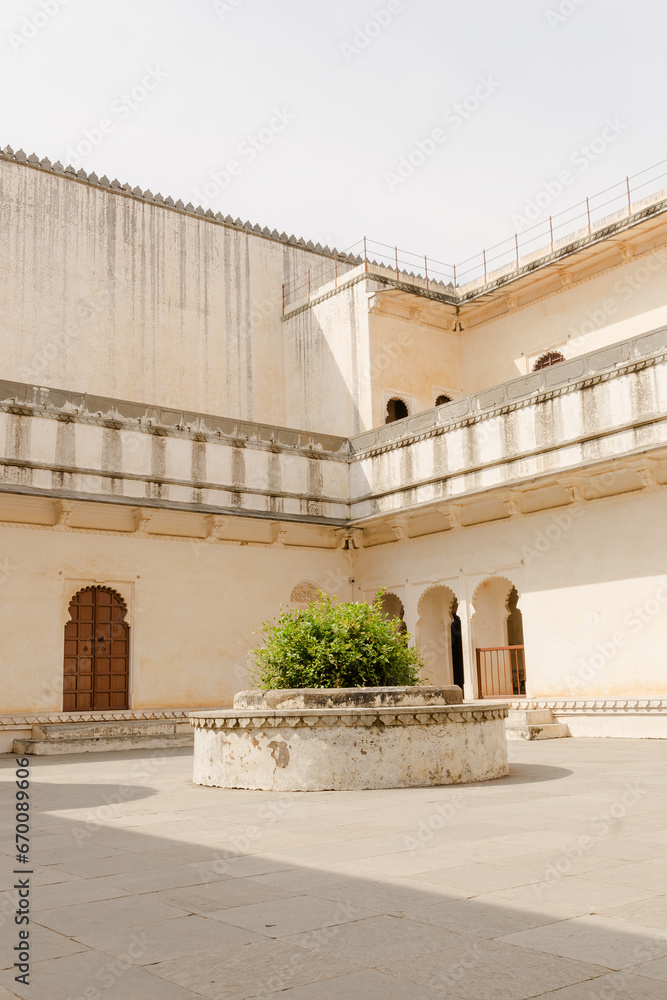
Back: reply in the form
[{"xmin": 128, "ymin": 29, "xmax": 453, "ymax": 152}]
[{"xmin": 461, "ymin": 248, "xmax": 667, "ymax": 393}]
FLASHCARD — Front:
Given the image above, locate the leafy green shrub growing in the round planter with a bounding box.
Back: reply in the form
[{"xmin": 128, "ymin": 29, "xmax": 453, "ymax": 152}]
[{"xmin": 251, "ymin": 590, "xmax": 423, "ymax": 690}]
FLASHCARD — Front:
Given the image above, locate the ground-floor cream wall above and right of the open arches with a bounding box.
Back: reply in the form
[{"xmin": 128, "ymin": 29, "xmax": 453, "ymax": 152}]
[{"xmin": 355, "ymin": 490, "xmax": 667, "ymax": 698}]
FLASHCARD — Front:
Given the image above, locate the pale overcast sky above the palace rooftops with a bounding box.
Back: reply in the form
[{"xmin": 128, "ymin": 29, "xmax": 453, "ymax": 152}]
[{"xmin": 0, "ymin": 0, "xmax": 667, "ymax": 262}]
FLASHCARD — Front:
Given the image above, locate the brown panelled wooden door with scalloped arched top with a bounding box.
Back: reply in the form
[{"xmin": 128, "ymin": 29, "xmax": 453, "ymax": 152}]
[{"xmin": 63, "ymin": 587, "xmax": 130, "ymax": 712}]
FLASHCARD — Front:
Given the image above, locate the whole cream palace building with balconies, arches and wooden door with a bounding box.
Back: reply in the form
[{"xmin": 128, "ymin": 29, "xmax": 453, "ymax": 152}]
[{"xmin": 0, "ymin": 148, "xmax": 667, "ymax": 750}]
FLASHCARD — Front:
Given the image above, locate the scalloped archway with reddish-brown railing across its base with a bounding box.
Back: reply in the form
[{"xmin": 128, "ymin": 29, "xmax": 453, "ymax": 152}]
[{"xmin": 472, "ymin": 576, "xmax": 526, "ymax": 698}]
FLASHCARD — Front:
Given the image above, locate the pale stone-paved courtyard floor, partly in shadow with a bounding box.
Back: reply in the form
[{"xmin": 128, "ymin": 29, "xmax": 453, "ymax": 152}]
[{"xmin": 0, "ymin": 739, "xmax": 667, "ymax": 1000}]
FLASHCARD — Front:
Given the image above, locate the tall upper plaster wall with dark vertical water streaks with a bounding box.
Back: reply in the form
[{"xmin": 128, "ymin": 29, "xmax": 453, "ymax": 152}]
[{"xmin": 0, "ymin": 160, "xmax": 327, "ymax": 430}]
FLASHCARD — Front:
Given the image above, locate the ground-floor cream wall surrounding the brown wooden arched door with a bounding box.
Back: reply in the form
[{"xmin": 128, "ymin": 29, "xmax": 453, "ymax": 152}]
[{"xmin": 0, "ymin": 526, "xmax": 350, "ymax": 713}]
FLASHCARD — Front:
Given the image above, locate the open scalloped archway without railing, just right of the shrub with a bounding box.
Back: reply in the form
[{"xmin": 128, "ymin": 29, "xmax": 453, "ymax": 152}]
[{"xmin": 415, "ymin": 584, "xmax": 464, "ymax": 690}]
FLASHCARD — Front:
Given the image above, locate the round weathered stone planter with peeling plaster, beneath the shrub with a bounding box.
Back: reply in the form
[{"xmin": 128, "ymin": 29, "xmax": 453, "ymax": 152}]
[{"xmin": 190, "ymin": 686, "xmax": 509, "ymax": 791}]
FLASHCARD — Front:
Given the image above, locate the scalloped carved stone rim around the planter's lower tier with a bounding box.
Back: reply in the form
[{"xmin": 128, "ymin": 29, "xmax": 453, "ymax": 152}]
[{"xmin": 190, "ymin": 702, "xmax": 509, "ymax": 730}]
